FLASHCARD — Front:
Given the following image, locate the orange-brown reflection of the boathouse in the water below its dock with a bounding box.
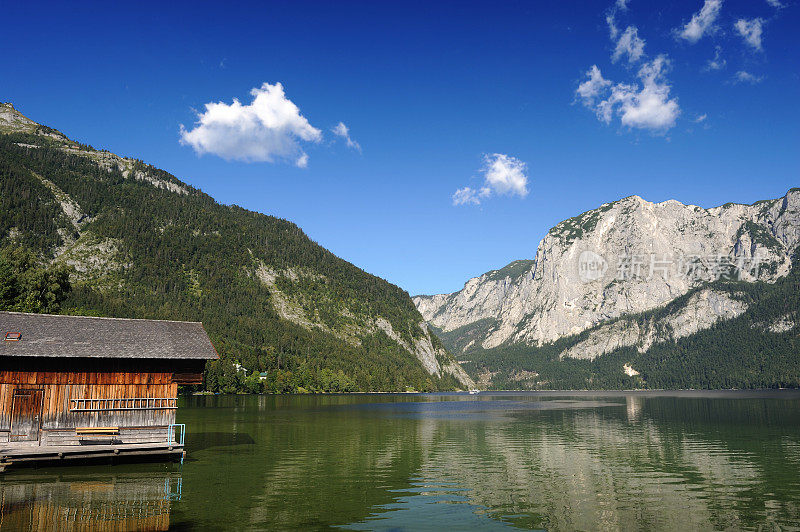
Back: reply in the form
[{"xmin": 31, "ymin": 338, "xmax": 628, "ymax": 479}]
[{"xmin": 0, "ymin": 467, "xmax": 182, "ymax": 531}]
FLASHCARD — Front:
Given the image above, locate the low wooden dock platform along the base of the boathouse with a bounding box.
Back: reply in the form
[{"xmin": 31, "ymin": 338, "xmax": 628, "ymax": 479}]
[{"xmin": 0, "ymin": 442, "xmax": 185, "ymax": 473}]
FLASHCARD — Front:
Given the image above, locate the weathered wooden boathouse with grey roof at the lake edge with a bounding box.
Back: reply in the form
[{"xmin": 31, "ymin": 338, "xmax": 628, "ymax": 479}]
[{"xmin": 0, "ymin": 312, "xmax": 218, "ymax": 470}]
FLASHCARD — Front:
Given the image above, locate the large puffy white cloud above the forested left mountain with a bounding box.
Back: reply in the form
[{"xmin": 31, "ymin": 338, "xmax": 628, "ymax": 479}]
[{"xmin": 181, "ymin": 83, "xmax": 322, "ymax": 168}]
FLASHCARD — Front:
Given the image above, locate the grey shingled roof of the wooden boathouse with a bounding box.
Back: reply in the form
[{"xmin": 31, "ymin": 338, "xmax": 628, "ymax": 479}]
[{"xmin": 0, "ymin": 312, "xmax": 217, "ymax": 360}]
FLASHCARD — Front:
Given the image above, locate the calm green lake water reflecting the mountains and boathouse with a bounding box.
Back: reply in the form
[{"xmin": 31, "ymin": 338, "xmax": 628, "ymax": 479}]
[{"xmin": 0, "ymin": 391, "xmax": 800, "ymax": 531}]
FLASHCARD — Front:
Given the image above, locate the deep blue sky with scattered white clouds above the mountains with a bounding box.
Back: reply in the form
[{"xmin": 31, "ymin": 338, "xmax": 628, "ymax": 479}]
[{"xmin": 0, "ymin": 0, "xmax": 800, "ymax": 294}]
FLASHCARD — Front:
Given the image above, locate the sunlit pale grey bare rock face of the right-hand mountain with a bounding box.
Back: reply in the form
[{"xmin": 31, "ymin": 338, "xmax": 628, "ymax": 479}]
[{"xmin": 414, "ymin": 189, "xmax": 800, "ymax": 357}]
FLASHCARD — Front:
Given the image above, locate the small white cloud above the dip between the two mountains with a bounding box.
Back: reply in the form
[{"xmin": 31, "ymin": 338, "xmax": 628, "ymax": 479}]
[{"xmin": 453, "ymin": 153, "xmax": 528, "ymax": 205}]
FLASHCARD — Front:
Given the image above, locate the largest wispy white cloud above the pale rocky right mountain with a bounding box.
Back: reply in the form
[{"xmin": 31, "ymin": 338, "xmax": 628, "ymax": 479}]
[{"xmin": 576, "ymin": 55, "xmax": 680, "ymax": 132}]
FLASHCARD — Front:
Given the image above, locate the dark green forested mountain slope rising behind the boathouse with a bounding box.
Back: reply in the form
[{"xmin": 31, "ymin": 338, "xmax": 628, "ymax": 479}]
[{"xmin": 0, "ymin": 103, "xmax": 473, "ymax": 391}]
